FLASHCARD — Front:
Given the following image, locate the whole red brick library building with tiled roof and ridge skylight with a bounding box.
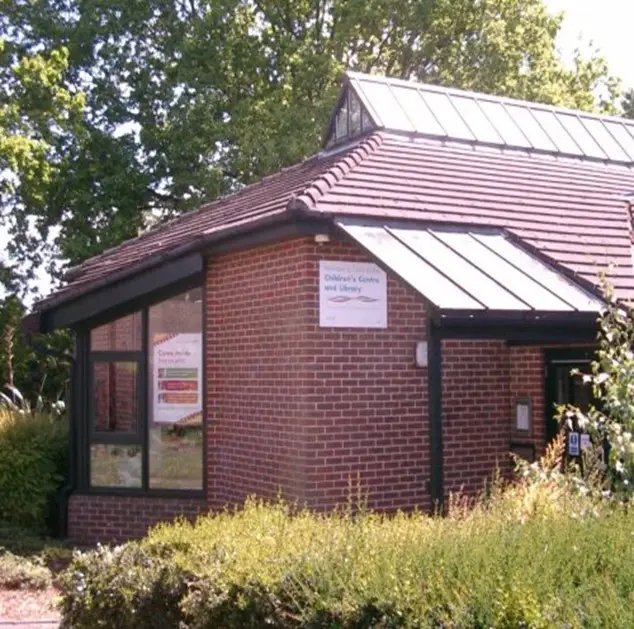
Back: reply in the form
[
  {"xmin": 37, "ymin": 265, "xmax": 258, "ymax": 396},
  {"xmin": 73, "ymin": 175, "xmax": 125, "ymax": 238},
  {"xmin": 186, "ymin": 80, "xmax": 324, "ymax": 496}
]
[{"xmin": 34, "ymin": 74, "xmax": 634, "ymax": 542}]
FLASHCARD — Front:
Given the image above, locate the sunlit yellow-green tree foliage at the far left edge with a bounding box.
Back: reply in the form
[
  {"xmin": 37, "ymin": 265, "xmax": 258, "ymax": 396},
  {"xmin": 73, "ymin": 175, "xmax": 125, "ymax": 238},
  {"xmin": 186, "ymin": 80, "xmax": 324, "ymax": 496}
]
[{"xmin": 0, "ymin": 39, "xmax": 84, "ymax": 291}]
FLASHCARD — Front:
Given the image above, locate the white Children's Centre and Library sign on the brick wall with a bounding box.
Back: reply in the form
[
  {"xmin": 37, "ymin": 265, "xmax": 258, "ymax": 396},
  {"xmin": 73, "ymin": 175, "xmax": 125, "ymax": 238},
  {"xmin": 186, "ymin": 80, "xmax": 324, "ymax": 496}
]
[{"xmin": 319, "ymin": 260, "xmax": 387, "ymax": 328}]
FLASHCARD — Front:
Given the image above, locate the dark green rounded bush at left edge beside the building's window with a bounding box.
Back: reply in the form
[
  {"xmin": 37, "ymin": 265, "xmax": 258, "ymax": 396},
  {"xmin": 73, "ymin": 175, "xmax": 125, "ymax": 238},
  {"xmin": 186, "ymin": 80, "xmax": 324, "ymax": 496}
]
[{"xmin": 0, "ymin": 407, "xmax": 68, "ymax": 530}]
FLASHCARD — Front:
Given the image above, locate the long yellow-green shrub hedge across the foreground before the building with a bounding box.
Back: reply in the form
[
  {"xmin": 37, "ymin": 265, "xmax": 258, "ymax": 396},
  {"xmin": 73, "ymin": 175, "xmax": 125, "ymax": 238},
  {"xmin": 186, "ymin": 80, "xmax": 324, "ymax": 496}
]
[{"xmin": 62, "ymin": 483, "xmax": 634, "ymax": 629}]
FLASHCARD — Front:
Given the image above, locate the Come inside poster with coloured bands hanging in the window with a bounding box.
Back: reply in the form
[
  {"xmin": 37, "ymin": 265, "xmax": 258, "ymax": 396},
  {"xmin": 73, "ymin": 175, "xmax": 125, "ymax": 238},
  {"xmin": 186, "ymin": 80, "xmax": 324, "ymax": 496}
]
[{"xmin": 152, "ymin": 333, "xmax": 203, "ymax": 425}]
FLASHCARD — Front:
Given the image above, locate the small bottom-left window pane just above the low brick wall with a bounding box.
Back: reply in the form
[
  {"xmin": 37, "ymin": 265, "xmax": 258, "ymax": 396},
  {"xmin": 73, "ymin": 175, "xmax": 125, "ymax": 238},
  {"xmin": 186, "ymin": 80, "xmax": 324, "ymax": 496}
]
[{"xmin": 90, "ymin": 444, "xmax": 143, "ymax": 487}]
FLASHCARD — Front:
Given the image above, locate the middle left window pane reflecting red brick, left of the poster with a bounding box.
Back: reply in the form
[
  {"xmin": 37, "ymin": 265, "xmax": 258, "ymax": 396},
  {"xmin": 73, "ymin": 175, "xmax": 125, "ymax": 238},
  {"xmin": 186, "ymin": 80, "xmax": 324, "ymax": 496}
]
[{"xmin": 92, "ymin": 361, "xmax": 139, "ymax": 433}]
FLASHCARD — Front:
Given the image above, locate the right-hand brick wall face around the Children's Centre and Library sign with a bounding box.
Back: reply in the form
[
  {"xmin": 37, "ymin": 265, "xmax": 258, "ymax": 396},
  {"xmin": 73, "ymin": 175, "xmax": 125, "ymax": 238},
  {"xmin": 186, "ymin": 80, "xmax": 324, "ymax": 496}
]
[{"xmin": 304, "ymin": 243, "xmax": 430, "ymax": 510}]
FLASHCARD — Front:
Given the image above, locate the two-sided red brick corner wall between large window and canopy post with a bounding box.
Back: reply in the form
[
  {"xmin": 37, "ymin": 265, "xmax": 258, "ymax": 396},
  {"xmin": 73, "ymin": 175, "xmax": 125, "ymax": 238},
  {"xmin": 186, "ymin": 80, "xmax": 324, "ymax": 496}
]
[{"xmin": 207, "ymin": 238, "xmax": 429, "ymax": 508}]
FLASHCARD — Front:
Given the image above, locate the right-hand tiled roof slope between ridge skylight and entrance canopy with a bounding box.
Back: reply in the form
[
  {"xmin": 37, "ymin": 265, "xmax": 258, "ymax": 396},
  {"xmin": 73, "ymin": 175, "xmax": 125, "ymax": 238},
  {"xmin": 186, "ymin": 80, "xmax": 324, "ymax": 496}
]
[{"xmin": 298, "ymin": 132, "xmax": 634, "ymax": 299}]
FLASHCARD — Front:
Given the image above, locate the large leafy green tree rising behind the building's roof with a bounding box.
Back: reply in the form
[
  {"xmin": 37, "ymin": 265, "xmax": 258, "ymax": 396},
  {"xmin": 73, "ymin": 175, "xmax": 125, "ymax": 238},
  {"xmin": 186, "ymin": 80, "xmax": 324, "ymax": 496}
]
[{"xmin": 0, "ymin": 0, "xmax": 617, "ymax": 280}]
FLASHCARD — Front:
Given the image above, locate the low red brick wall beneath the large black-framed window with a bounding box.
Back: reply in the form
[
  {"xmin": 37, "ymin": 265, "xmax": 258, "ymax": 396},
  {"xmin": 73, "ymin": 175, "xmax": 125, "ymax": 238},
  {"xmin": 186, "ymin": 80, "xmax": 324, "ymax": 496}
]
[{"xmin": 68, "ymin": 495, "xmax": 205, "ymax": 544}]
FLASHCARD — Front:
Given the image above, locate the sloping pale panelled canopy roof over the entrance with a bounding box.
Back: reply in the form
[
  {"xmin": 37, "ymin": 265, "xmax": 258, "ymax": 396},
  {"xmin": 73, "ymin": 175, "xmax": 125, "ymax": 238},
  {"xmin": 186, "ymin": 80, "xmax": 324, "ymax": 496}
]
[{"xmin": 337, "ymin": 219, "xmax": 604, "ymax": 318}]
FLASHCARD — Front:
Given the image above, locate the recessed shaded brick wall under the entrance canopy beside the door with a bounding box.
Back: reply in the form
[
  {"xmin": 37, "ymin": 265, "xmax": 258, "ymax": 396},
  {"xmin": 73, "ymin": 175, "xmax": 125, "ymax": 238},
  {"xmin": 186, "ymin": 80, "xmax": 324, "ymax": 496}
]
[{"xmin": 442, "ymin": 340, "xmax": 546, "ymax": 495}]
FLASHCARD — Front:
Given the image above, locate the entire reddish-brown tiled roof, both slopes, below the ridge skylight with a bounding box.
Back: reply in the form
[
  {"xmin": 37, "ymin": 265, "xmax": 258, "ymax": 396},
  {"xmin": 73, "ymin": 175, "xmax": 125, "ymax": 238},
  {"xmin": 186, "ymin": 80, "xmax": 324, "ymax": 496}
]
[{"xmin": 40, "ymin": 132, "xmax": 634, "ymax": 308}]
